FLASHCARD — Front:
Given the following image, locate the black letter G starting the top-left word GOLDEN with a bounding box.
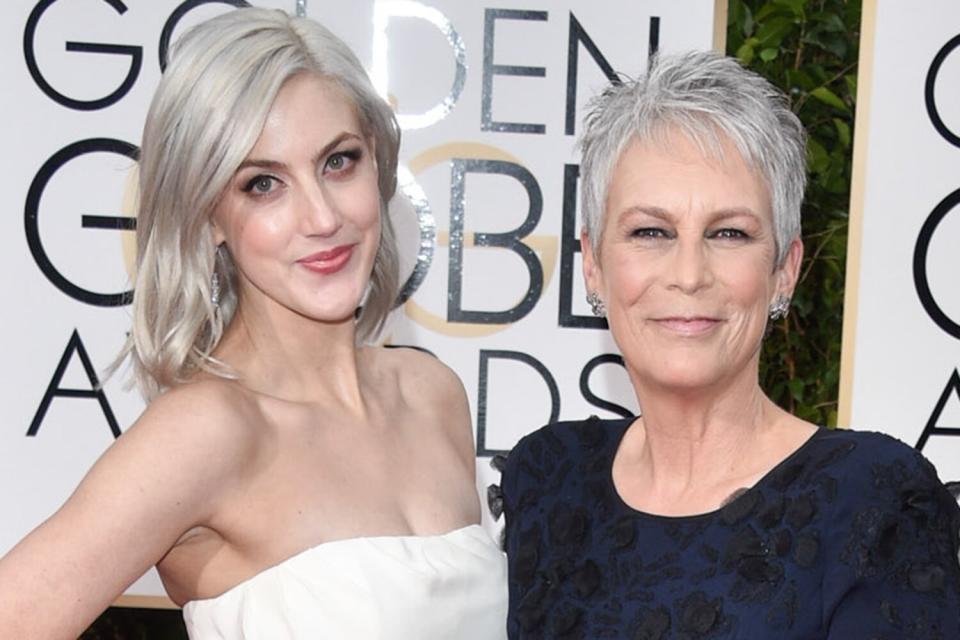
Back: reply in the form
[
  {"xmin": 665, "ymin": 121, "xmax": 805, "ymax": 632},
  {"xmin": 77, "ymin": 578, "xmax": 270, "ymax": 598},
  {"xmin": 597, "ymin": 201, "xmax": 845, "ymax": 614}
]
[{"xmin": 23, "ymin": 0, "xmax": 143, "ymax": 111}]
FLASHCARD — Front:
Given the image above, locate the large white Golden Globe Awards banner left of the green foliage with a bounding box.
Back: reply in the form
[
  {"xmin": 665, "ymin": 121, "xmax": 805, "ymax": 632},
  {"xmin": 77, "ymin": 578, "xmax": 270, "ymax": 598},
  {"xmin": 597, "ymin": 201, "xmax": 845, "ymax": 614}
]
[{"xmin": 0, "ymin": 0, "xmax": 720, "ymax": 604}]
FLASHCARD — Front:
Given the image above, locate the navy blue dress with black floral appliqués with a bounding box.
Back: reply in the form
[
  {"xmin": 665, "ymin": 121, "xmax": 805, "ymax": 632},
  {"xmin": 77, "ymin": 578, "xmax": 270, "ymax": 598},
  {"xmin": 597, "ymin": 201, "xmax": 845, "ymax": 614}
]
[{"xmin": 502, "ymin": 418, "xmax": 960, "ymax": 640}]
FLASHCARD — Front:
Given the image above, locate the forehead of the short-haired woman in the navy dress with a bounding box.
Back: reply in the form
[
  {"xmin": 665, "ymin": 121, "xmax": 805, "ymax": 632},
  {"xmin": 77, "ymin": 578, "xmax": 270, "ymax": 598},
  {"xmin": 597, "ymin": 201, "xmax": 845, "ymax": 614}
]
[{"xmin": 605, "ymin": 129, "xmax": 772, "ymax": 223}]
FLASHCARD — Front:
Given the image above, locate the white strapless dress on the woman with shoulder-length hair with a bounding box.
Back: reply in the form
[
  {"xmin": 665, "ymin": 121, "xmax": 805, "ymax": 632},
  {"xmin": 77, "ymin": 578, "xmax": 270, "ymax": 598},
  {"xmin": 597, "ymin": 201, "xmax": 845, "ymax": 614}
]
[{"xmin": 183, "ymin": 525, "xmax": 507, "ymax": 640}]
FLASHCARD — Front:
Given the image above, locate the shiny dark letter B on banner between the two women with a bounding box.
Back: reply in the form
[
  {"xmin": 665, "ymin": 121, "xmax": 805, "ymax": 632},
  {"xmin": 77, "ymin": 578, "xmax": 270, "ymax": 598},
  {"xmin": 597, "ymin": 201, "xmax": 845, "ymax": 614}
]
[{"xmin": 447, "ymin": 158, "xmax": 543, "ymax": 324}]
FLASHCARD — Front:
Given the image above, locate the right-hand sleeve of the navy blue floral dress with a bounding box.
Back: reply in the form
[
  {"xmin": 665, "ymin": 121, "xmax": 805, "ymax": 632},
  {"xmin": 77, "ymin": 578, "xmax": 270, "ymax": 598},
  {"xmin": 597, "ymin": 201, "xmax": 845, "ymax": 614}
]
[{"xmin": 823, "ymin": 444, "xmax": 960, "ymax": 640}]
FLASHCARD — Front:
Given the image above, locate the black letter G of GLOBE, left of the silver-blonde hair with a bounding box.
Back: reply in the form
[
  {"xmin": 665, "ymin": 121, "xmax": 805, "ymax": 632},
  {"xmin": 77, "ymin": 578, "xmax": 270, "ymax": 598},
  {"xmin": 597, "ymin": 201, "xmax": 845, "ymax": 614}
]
[{"xmin": 24, "ymin": 138, "xmax": 137, "ymax": 307}]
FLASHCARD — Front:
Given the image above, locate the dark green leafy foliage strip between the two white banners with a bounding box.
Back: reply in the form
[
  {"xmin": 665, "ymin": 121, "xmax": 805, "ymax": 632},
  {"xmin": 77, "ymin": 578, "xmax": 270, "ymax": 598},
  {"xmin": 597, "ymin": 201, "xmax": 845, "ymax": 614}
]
[{"xmin": 727, "ymin": 0, "xmax": 860, "ymax": 426}]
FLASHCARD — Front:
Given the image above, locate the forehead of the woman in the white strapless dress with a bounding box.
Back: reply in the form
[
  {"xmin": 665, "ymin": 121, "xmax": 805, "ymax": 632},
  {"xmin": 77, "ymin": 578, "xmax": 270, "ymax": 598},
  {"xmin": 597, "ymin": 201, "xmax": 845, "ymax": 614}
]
[{"xmin": 251, "ymin": 73, "xmax": 361, "ymax": 155}]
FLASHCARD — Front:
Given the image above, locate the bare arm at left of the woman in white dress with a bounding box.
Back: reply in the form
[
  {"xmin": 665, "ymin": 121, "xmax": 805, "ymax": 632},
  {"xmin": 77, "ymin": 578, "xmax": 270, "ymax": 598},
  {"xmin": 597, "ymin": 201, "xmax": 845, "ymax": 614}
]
[{"xmin": 0, "ymin": 382, "xmax": 251, "ymax": 638}]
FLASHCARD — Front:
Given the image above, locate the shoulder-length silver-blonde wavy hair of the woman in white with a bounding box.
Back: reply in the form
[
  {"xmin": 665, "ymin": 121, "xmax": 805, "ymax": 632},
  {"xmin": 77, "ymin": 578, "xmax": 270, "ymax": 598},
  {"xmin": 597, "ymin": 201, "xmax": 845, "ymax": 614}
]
[{"xmin": 120, "ymin": 8, "xmax": 400, "ymax": 399}]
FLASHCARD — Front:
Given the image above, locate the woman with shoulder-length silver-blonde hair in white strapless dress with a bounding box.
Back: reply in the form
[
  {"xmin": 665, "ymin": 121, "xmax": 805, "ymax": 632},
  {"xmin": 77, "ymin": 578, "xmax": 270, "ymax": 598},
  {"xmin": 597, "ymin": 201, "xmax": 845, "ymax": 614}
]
[{"xmin": 0, "ymin": 9, "xmax": 507, "ymax": 640}]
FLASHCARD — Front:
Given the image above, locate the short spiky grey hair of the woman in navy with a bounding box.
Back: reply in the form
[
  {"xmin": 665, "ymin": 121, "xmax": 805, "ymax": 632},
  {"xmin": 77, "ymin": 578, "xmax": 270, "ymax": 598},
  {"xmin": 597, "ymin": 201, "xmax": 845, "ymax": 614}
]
[{"xmin": 579, "ymin": 51, "xmax": 806, "ymax": 266}]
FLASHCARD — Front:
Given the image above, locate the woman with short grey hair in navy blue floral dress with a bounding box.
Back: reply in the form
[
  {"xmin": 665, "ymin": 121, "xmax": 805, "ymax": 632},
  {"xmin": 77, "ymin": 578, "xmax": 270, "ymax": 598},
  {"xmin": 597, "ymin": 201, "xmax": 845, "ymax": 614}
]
[{"xmin": 503, "ymin": 53, "xmax": 960, "ymax": 640}]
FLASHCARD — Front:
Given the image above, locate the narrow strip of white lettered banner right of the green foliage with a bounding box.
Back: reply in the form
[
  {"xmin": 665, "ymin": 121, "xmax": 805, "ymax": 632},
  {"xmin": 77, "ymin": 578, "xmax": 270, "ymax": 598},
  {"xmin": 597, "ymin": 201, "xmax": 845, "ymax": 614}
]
[{"xmin": 839, "ymin": 0, "xmax": 960, "ymax": 480}]
